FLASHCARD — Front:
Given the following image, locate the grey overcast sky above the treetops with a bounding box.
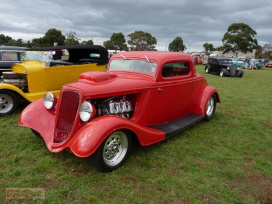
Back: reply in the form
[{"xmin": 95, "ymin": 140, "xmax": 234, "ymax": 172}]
[{"xmin": 0, "ymin": 0, "xmax": 272, "ymax": 52}]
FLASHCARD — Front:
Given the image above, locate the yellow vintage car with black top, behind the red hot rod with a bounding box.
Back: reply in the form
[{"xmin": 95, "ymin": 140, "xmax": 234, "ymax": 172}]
[{"xmin": 0, "ymin": 45, "xmax": 108, "ymax": 116}]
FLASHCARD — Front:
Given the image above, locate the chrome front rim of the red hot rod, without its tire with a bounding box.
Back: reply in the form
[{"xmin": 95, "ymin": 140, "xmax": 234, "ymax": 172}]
[{"xmin": 103, "ymin": 131, "xmax": 128, "ymax": 166}]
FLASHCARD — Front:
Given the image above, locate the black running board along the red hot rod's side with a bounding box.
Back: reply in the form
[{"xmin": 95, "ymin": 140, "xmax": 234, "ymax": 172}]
[{"xmin": 149, "ymin": 113, "xmax": 203, "ymax": 138}]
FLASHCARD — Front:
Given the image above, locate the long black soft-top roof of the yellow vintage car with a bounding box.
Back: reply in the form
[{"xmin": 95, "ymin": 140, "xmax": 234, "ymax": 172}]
[{"xmin": 29, "ymin": 45, "xmax": 109, "ymax": 65}]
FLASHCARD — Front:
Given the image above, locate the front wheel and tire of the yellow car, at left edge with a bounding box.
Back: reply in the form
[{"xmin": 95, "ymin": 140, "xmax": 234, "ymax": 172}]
[{"xmin": 0, "ymin": 90, "xmax": 18, "ymax": 117}]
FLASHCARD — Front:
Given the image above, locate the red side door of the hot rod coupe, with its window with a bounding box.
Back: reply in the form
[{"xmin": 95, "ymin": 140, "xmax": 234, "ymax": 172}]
[{"xmin": 149, "ymin": 63, "xmax": 193, "ymax": 124}]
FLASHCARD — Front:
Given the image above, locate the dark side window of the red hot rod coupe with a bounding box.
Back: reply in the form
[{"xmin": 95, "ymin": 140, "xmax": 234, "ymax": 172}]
[{"xmin": 162, "ymin": 62, "xmax": 190, "ymax": 77}]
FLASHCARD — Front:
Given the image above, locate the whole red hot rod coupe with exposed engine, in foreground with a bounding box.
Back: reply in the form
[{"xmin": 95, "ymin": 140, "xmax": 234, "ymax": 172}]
[{"xmin": 19, "ymin": 51, "xmax": 221, "ymax": 172}]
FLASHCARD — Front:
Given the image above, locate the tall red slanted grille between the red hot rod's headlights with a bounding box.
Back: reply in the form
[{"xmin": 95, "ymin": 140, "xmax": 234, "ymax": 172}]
[{"xmin": 53, "ymin": 91, "xmax": 80, "ymax": 143}]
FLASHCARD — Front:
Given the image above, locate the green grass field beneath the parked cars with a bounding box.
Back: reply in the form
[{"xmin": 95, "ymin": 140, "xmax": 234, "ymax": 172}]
[{"xmin": 0, "ymin": 65, "xmax": 272, "ymax": 204}]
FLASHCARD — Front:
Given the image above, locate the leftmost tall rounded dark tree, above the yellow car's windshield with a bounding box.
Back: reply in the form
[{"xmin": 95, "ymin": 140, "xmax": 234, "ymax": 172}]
[{"xmin": 42, "ymin": 28, "xmax": 65, "ymax": 47}]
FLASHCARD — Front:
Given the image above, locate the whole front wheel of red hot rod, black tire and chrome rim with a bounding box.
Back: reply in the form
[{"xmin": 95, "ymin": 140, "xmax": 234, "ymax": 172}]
[{"xmin": 90, "ymin": 130, "xmax": 131, "ymax": 173}]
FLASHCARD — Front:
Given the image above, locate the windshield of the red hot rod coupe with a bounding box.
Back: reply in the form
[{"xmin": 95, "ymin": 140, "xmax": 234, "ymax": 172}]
[{"xmin": 109, "ymin": 59, "xmax": 157, "ymax": 76}]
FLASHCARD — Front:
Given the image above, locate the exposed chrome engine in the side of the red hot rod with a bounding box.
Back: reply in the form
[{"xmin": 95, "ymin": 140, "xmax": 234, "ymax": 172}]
[{"xmin": 91, "ymin": 95, "xmax": 134, "ymax": 119}]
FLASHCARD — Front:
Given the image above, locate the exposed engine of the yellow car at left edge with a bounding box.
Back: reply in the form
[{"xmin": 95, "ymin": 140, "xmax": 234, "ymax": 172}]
[{"xmin": 0, "ymin": 72, "xmax": 27, "ymax": 91}]
